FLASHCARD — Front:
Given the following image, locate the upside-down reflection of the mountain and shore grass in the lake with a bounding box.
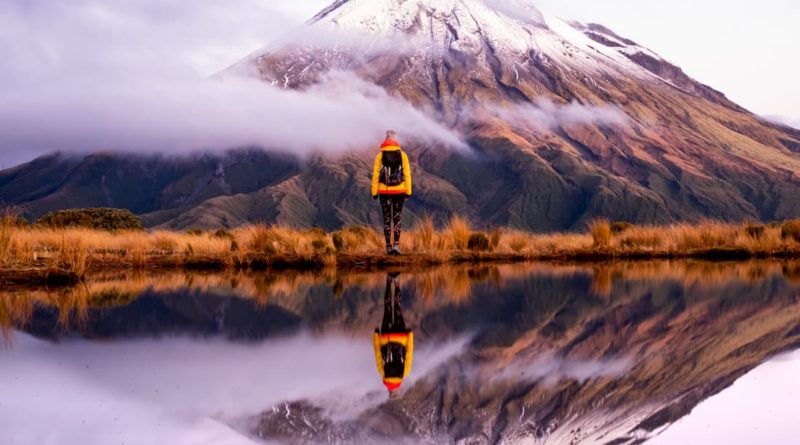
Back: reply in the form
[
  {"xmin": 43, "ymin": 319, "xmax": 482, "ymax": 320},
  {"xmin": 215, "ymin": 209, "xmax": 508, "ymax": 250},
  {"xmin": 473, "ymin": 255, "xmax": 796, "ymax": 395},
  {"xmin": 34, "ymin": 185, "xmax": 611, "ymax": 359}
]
[{"xmin": 0, "ymin": 262, "xmax": 800, "ymax": 443}]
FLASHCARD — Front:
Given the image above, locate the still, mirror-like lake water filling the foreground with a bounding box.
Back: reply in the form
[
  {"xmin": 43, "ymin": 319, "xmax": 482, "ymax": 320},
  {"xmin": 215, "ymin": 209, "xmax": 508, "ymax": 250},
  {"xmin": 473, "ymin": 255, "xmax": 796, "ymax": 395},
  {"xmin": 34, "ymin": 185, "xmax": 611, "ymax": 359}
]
[{"xmin": 0, "ymin": 261, "xmax": 800, "ymax": 445}]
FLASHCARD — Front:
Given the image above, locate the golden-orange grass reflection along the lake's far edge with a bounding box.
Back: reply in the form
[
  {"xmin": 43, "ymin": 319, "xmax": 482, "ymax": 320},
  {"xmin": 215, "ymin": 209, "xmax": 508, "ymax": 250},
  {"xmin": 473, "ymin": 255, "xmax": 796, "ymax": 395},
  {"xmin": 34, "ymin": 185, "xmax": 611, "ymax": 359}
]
[{"xmin": 0, "ymin": 261, "xmax": 800, "ymax": 342}]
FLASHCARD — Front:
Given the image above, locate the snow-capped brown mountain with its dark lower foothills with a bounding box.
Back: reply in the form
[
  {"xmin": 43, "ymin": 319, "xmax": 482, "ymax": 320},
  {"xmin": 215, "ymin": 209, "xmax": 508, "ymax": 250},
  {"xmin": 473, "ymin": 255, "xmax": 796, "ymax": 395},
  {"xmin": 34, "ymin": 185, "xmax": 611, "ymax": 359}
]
[{"xmin": 0, "ymin": 0, "xmax": 800, "ymax": 231}]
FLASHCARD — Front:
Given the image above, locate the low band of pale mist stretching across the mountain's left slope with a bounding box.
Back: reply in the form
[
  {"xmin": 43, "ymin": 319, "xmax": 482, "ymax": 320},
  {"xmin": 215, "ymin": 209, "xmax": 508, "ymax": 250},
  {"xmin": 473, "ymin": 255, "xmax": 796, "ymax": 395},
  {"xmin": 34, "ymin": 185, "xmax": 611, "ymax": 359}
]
[{"xmin": 0, "ymin": 72, "xmax": 460, "ymax": 158}]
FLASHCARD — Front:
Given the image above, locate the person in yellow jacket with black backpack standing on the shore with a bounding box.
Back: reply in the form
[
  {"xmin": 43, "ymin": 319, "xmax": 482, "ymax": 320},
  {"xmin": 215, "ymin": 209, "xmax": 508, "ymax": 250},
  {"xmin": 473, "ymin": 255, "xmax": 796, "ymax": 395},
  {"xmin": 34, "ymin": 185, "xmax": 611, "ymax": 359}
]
[{"xmin": 372, "ymin": 130, "xmax": 411, "ymax": 255}]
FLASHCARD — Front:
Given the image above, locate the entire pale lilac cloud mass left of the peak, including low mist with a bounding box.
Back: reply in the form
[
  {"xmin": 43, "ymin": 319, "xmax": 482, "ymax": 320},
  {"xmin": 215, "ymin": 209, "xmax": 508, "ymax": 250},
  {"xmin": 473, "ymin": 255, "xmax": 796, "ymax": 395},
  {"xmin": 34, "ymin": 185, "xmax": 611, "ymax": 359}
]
[{"xmin": 0, "ymin": 0, "xmax": 460, "ymax": 164}]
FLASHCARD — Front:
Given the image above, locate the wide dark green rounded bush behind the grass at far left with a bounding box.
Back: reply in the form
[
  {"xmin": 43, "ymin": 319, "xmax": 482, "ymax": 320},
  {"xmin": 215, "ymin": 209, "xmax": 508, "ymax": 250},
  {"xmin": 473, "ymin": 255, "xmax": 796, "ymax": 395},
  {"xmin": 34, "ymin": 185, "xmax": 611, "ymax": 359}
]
[{"xmin": 36, "ymin": 208, "xmax": 143, "ymax": 231}]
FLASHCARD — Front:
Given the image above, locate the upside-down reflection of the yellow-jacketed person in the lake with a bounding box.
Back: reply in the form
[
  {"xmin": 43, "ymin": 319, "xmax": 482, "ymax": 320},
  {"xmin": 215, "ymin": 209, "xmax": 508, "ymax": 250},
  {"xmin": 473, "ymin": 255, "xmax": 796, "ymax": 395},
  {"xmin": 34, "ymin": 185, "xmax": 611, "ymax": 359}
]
[{"xmin": 372, "ymin": 273, "xmax": 414, "ymax": 398}]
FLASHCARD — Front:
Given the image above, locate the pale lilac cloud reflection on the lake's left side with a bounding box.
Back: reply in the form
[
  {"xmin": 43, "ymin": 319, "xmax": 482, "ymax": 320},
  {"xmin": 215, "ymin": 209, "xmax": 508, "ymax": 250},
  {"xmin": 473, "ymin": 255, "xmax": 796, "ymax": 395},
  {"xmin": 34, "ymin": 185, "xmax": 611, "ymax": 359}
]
[{"xmin": 0, "ymin": 333, "xmax": 472, "ymax": 445}]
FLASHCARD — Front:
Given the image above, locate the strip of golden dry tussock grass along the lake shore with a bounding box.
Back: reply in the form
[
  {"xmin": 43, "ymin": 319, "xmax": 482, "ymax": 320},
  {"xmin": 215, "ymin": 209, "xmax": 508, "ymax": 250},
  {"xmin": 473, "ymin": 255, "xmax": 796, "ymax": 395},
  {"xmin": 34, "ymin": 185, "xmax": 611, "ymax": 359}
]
[{"xmin": 0, "ymin": 217, "xmax": 800, "ymax": 285}]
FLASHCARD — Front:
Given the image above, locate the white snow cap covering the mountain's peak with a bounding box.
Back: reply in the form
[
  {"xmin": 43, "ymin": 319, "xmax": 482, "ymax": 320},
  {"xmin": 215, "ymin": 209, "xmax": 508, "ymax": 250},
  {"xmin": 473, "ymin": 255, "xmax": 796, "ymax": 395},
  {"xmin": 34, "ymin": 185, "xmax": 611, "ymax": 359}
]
[{"xmin": 251, "ymin": 0, "xmax": 670, "ymax": 88}]
